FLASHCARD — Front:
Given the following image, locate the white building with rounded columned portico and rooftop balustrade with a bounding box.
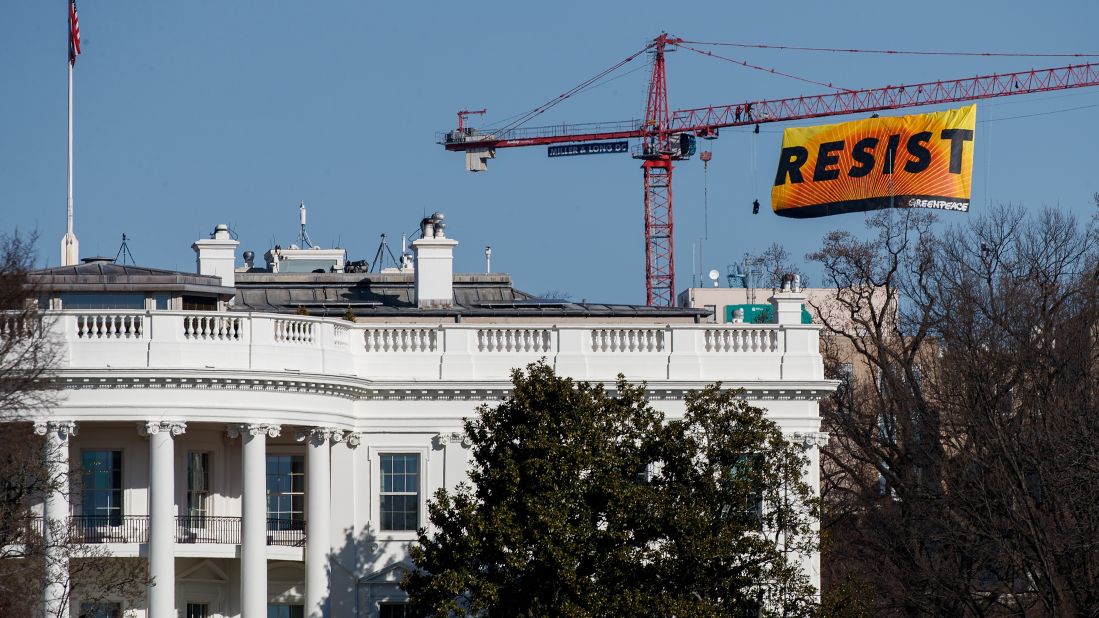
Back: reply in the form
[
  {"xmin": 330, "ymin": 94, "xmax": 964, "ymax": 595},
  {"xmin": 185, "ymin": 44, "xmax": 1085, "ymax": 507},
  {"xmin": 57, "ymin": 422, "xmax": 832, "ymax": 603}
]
[{"xmin": 23, "ymin": 217, "xmax": 834, "ymax": 618}]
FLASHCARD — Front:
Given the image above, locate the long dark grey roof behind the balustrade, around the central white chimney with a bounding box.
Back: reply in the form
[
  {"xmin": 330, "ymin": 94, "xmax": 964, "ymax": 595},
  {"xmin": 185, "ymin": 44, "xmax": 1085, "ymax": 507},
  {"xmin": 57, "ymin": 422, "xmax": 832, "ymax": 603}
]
[{"xmin": 233, "ymin": 273, "xmax": 709, "ymax": 318}]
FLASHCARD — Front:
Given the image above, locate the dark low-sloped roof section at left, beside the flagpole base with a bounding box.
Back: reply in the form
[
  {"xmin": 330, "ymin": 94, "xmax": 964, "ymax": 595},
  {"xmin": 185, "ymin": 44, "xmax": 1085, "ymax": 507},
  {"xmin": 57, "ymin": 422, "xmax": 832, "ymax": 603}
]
[{"xmin": 30, "ymin": 261, "xmax": 235, "ymax": 297}]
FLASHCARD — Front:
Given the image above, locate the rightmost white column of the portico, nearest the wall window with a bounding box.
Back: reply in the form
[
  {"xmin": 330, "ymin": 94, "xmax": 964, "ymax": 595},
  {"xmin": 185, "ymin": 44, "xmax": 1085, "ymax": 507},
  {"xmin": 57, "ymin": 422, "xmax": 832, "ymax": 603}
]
[{"xmin": 298, "ymin": 427, "xmax": 331, "ymax": 618}]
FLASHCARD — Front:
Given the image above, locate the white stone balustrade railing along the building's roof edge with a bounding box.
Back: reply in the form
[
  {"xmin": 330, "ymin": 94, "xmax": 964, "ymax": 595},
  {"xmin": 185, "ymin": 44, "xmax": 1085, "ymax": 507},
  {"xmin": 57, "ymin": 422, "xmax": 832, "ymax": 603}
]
[{"xmin": 53, "ymin": 310, "xmax": 823, "ymax": 382}]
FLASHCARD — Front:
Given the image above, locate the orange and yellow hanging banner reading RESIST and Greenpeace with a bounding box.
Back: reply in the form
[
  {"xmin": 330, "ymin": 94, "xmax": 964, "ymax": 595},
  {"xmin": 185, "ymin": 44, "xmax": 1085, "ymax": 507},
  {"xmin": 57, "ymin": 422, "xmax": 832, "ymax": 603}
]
[{"xmin": 770, "ymin": 106, "xmax": 977, "ymax": 218}]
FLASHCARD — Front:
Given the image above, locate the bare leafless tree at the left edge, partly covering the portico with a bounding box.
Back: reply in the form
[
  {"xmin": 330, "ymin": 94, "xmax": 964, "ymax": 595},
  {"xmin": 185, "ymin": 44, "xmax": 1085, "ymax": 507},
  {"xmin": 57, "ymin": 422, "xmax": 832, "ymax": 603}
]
[{"xmin": 0, "ymin": 232, "xmax": 148, "ymax": 616}]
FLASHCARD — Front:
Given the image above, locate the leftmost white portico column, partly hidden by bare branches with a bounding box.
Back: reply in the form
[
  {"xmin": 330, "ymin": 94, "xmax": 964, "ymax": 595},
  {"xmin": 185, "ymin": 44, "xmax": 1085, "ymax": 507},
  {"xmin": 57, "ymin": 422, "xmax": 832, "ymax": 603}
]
[{"xmin": 34, "ymin": 421, "xmax": 76, "ymax": 618}]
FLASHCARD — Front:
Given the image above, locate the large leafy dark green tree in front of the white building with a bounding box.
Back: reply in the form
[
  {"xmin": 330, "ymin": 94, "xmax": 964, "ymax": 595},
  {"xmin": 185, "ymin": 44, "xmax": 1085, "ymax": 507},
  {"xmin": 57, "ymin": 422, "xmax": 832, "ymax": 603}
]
[{"xmin": 402, "ymin": 363, "xmax": 815, "ymax": 617}]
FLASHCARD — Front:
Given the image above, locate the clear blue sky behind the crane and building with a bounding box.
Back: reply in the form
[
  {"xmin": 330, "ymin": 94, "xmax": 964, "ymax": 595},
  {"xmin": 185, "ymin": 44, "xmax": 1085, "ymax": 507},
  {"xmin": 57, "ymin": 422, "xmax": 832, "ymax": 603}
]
[{"xmin": 0, "ymin": 0, "xmax": 1099, "ymax": 302}]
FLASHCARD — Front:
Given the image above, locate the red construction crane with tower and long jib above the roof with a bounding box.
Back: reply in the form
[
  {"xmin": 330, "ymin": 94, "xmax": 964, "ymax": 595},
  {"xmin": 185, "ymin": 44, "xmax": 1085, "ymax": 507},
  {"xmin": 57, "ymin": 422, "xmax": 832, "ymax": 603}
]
[{"xmin": 439, "ymin": 34, "xmax": 1099, "ymax": 307}]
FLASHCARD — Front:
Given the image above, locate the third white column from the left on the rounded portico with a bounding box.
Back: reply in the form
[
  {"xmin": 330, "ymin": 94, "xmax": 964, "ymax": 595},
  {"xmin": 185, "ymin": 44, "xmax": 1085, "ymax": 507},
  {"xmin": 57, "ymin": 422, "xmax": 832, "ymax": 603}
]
[{"xmin": 229, "ymin": 424, "xmax": 281, "ymax": 618}]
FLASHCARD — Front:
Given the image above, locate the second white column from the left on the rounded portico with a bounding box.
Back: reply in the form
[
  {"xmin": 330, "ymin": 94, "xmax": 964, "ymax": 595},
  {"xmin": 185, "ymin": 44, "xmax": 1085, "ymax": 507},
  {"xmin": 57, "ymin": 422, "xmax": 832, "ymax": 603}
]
[{"xmin": 137, "ymin": 421, "xmax": 187, "ymax": 617}]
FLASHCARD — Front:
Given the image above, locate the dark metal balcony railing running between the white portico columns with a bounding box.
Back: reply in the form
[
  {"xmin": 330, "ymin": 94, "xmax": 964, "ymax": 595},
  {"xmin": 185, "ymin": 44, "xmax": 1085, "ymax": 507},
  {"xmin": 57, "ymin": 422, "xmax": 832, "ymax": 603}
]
[{"xmin": 51, "ymin": 515, "xmax": 306, "ymax": 548}]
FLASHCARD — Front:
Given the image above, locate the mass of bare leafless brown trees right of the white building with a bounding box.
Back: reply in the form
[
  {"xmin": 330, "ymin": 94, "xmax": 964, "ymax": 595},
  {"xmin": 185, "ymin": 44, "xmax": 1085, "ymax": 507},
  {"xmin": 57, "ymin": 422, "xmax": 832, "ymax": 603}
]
[{"xmin": 811, "ymin": 208, "xmax": 1099, "ymax": 616}]
